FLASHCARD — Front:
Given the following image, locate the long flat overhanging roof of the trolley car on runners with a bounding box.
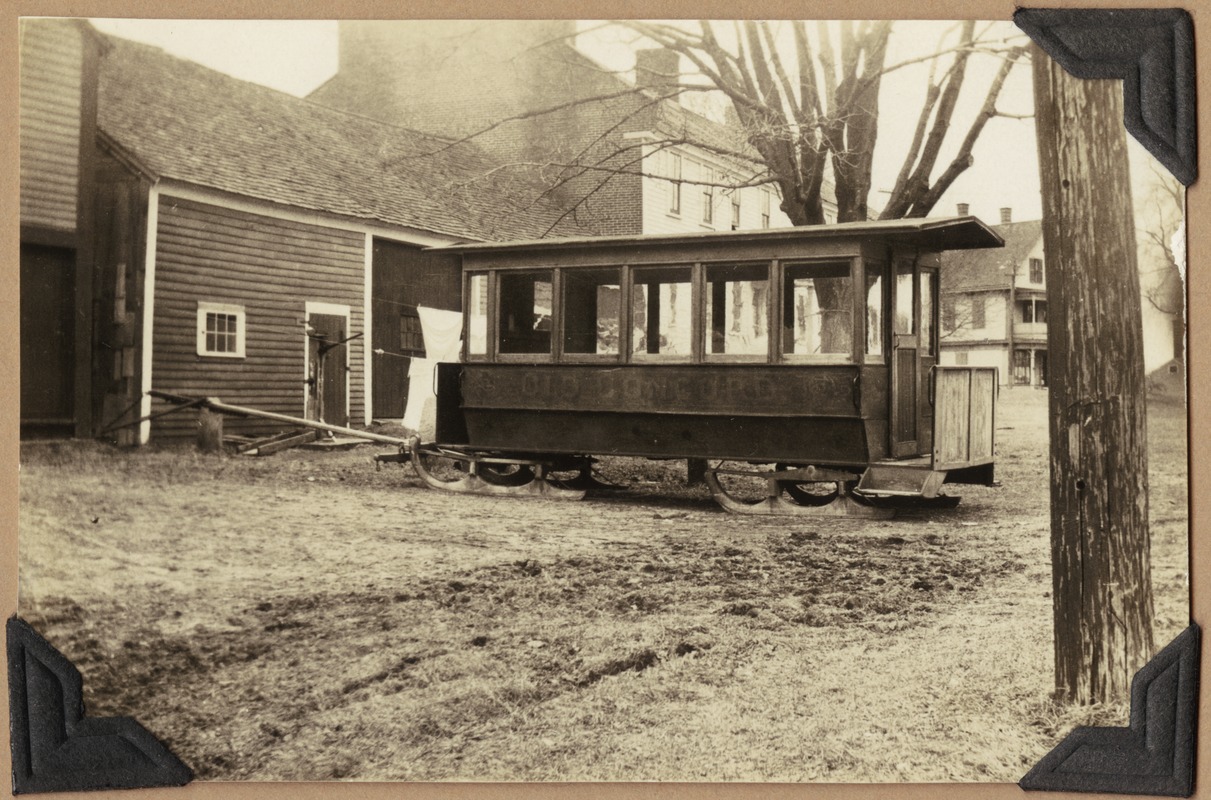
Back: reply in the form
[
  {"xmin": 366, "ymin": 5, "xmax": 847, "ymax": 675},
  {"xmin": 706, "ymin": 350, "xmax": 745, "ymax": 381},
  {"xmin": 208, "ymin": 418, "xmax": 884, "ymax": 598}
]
[{"xmin": 431, "ymin": 217, "xmax": 1005, "ymax": 253}]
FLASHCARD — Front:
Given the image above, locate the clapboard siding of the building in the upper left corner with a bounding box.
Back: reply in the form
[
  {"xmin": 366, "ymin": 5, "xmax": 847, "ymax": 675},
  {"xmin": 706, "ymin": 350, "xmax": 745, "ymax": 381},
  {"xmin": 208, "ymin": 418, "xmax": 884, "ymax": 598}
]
[{"xmin": 19, "ymin": 19, "xmax": 85, "ymax": 231}]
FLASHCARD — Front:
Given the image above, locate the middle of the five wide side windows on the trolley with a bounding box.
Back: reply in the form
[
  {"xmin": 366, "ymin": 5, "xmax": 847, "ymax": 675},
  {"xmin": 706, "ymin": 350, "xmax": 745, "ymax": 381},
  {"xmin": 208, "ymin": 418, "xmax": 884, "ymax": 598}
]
[{"xmin": 631, "ymin": 266, "xmax": 694, "ymax": 356}]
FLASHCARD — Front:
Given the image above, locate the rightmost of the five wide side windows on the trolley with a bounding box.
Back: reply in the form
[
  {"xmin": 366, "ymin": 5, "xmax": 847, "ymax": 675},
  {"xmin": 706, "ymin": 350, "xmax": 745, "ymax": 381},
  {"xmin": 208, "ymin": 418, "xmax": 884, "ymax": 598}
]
[{"xmin": 782, "ymin": 261, "xmax": 854, "ymax": 356}]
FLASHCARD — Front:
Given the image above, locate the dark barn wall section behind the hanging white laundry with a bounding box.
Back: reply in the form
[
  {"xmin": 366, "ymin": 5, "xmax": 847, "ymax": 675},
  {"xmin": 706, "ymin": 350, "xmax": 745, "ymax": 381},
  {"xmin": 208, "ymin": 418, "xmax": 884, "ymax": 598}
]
[{"xmin": 371, "ymin": 238, "xmax": 461, "ymax": 420}]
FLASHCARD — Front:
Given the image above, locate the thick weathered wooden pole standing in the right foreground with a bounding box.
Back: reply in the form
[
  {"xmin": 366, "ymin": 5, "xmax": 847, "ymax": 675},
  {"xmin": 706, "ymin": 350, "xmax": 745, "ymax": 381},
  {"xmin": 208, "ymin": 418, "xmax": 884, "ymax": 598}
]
[{"xmin": 1033, "ymin": 48, "xmax": 1153, "ymax": 703}]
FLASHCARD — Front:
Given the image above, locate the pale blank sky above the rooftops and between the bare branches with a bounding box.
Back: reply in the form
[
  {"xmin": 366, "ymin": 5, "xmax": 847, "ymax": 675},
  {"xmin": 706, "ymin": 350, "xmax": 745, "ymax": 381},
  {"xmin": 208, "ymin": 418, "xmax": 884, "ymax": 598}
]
[{"xmin": 92, "ymin": 19, "xmax": 1041, "ymax": 224}]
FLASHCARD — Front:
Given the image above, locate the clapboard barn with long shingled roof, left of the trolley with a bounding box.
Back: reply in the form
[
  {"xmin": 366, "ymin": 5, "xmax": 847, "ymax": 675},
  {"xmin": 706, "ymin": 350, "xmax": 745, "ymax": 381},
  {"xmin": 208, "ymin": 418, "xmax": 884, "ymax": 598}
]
[{"xmin": 21, "ymin": 19, "xmax": 586, "ymax": 443}]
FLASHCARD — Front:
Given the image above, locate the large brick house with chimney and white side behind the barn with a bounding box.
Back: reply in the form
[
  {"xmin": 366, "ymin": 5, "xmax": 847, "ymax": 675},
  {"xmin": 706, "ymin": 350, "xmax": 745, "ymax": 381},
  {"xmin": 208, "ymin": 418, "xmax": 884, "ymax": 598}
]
[{"xmin": 309, "ymin": 19, "xmax": 837, "ymax": 235}]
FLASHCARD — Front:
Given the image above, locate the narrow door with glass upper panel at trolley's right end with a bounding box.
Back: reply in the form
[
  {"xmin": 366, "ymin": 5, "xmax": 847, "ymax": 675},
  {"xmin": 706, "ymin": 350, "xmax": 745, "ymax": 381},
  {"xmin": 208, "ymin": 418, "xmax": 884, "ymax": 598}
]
[{"xmin": 890, "ymin": 258, "xmax": 922, "ymax": 457}]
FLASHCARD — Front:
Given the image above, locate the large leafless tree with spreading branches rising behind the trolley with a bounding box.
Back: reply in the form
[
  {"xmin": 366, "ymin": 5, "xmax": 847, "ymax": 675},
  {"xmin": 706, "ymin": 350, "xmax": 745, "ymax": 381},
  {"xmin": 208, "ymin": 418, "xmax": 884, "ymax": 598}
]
[{"xmin": 411, "ymin": 21, "xmax": 1027, "ymax": 231}]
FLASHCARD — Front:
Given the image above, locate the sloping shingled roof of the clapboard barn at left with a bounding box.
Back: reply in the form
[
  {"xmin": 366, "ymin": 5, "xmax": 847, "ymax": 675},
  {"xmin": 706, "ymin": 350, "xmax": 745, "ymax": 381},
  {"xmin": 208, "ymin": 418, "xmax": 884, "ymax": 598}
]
[{"xmin": 98, "ymin": 36, "xmax": 595, "ymax": 240}]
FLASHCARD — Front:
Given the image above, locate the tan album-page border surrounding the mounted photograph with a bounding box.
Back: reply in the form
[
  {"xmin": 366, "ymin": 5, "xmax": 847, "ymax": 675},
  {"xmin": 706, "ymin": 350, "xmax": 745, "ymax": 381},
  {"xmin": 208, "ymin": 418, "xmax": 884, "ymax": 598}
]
[{"xmin": 7, "ymin": 0, "xmax": 1211, "ymax": 799}]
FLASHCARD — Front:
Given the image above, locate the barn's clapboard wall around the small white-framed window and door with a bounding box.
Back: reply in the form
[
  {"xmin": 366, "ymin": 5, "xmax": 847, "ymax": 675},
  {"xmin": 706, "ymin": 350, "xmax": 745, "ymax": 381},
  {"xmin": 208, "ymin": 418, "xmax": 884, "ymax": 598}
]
[{"xmin": 151, "ymin": 196, "xmax": 366, "ymax": 441}]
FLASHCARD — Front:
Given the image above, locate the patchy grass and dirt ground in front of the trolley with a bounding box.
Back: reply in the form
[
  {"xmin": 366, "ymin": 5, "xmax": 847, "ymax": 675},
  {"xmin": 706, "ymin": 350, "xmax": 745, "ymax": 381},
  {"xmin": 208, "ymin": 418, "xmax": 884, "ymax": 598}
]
[{"xmin": 19, "ymin": 390, "xmax": 1188, "ymax": 782}]
